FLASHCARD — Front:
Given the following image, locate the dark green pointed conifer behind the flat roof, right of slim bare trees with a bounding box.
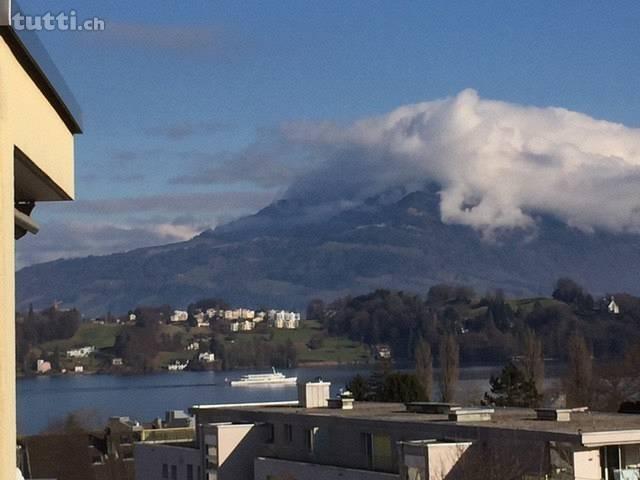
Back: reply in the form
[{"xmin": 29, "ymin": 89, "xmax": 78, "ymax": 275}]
[{"xmin": 484, "ymin": 362, "xmax": 541, "ymax": 408}]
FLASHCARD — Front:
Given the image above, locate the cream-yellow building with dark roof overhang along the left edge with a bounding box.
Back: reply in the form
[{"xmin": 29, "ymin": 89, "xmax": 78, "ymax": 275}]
[{"xmin": 0, "ymin": 0, "xmax": 81, "ymax": 479}]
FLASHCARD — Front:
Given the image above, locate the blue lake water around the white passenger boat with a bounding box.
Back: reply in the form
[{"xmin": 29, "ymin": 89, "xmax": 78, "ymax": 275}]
[{"xmin": 17, "ymin": 366, "xmax": 560, "ymax": 435}]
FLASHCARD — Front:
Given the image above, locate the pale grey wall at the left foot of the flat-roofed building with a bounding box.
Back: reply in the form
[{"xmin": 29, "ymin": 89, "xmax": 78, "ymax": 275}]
[{"xmin": 134, "ymin": 443, "xmax": 202, "ymax": 480}]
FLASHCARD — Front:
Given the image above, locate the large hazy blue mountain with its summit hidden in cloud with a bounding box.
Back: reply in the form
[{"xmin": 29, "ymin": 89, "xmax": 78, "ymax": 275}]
[{"xmin": 17, "ymin": 189, "xmax": 640, "ymax": 315}]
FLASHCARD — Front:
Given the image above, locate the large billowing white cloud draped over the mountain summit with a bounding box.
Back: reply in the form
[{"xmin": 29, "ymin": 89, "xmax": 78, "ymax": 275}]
[{"xmin": 282, "ymin": 90, "xmax": 640, "ymax": 235}]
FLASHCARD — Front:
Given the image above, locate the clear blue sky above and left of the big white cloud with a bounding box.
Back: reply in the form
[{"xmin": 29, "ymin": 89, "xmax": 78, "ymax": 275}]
[{"xmin": 13, "ymin": 0, "xmax": 640, "ymax": 266}]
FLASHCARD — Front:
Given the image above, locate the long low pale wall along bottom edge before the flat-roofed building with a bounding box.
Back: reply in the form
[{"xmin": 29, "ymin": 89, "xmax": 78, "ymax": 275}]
[{"xmin": 253, "ymin": 457, "xmax": 399, "ymax": 480}]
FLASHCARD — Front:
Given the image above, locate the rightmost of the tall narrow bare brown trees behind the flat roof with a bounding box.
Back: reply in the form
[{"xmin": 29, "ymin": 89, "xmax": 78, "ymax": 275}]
[{"xmin": 564, "ymin": 334, "xmax": 593, "ymax": 407}]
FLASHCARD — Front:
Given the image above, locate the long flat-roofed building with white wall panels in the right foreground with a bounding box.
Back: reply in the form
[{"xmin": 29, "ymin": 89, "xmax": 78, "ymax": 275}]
[{"xmin": 136, "ymin": 382, "xmax": 640, "ymax": 480}]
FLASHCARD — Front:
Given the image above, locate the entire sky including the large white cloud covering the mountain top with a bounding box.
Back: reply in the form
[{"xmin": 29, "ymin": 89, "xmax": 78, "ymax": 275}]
[{"xmin": 17, "ymin": 0, "xmax": 640, "ymax": 268}]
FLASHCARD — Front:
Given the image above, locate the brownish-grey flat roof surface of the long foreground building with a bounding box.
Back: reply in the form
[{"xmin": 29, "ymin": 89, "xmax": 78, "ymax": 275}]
[{"xmin": 191, "ymin": 402, "xmax": 640, "ymax": 435}]
